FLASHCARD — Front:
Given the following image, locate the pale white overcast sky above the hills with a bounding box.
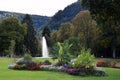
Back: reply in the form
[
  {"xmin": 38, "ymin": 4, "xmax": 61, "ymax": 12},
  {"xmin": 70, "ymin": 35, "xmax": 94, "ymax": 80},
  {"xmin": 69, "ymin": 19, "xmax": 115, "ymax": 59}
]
[{"xmin": 0, "ymin": 0, "xmax": 77, "ymax": 16}]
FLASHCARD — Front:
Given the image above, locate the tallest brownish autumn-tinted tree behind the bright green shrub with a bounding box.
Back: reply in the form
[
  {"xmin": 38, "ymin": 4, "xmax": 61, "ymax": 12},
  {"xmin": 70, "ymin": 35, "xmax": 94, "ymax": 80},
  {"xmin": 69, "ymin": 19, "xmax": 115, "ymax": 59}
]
[{"xmin": 72, "ymin": 11, "xmax": 99, "ymax": 48}]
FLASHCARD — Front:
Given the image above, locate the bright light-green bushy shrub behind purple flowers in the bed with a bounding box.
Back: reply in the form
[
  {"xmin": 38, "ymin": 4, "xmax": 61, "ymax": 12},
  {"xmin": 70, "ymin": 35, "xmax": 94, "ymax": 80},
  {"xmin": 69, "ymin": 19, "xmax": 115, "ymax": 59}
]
[{"xmin": 72, "ymin": 48, "xmax": 95, "ymax": 68}]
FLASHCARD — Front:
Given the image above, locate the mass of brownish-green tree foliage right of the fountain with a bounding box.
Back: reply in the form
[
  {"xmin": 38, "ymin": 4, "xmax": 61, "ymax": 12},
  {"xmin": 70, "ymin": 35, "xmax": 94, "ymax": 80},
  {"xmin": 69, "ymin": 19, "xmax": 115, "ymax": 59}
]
[{"xmin": 52, "ymin": 10, "xmax": 101, "ymax": 56}]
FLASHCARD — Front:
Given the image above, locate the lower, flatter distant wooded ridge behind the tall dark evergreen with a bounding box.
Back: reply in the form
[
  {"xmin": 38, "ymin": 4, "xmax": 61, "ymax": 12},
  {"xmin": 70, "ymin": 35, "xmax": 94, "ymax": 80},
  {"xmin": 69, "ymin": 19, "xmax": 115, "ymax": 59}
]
[{"xmin": 0, "ymin": 11, "xmax": 50, "ymax": 30}]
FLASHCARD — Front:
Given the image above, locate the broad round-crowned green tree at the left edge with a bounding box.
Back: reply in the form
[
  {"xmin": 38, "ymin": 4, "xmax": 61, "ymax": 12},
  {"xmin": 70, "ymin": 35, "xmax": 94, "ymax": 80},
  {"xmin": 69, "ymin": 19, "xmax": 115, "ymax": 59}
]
[{"xmin": 0, "ymin": 18, "xmax": 26, "ymax": 53}]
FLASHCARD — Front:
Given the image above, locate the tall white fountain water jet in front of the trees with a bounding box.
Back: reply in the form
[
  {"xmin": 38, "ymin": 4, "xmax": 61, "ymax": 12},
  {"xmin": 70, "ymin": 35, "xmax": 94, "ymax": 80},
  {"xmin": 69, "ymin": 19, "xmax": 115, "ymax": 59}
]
[{"xmin": 42, "ymin": 36, "xmax": 49, "ymax": 58}]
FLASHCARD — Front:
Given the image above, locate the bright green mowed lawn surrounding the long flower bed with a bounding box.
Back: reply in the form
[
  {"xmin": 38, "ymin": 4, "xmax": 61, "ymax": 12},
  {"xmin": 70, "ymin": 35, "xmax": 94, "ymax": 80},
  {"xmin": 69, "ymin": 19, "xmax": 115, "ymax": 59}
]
[{"xmin": 0, "ymin": 58, "xmax": 120, "ymax": 80}]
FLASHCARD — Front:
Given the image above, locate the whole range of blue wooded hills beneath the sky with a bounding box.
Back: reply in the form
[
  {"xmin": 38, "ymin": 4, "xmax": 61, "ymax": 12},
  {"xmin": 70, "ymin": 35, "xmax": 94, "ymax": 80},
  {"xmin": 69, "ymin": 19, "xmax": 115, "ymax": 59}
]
[{"xmin": 0, "ymin": 1, "xmax": 82, "ymax": 33}]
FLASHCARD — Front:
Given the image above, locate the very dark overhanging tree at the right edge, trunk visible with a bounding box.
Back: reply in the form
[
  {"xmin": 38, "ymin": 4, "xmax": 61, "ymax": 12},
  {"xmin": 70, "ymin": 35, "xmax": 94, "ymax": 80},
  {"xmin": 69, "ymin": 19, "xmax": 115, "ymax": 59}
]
[{"xmin": 82, "ymin": 0, "xmax": 120, "ymax": 58}]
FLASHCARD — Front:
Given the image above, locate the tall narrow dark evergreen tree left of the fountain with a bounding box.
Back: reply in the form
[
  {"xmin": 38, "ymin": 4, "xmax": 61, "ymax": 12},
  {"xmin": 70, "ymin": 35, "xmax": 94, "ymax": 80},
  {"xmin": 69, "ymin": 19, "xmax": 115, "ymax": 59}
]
[{"xmin": 22, "ymin": 14, "xmax": 37, "ymax": 56}]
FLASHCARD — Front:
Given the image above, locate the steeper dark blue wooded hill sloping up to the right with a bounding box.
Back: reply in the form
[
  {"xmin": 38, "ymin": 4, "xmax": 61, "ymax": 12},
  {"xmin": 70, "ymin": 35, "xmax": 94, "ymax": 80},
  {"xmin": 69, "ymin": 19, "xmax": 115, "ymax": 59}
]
[{"xmin": 48, "ymin": 1, "xmax": 82, "ymax": 30}]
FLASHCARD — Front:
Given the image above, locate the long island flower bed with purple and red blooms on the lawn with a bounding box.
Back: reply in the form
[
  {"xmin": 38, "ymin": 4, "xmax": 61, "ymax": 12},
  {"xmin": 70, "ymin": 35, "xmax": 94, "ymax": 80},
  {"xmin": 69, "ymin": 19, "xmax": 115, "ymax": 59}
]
[{"xmin": 8, "ymin": 50, "xmax": 106, "ymax": 76}]
